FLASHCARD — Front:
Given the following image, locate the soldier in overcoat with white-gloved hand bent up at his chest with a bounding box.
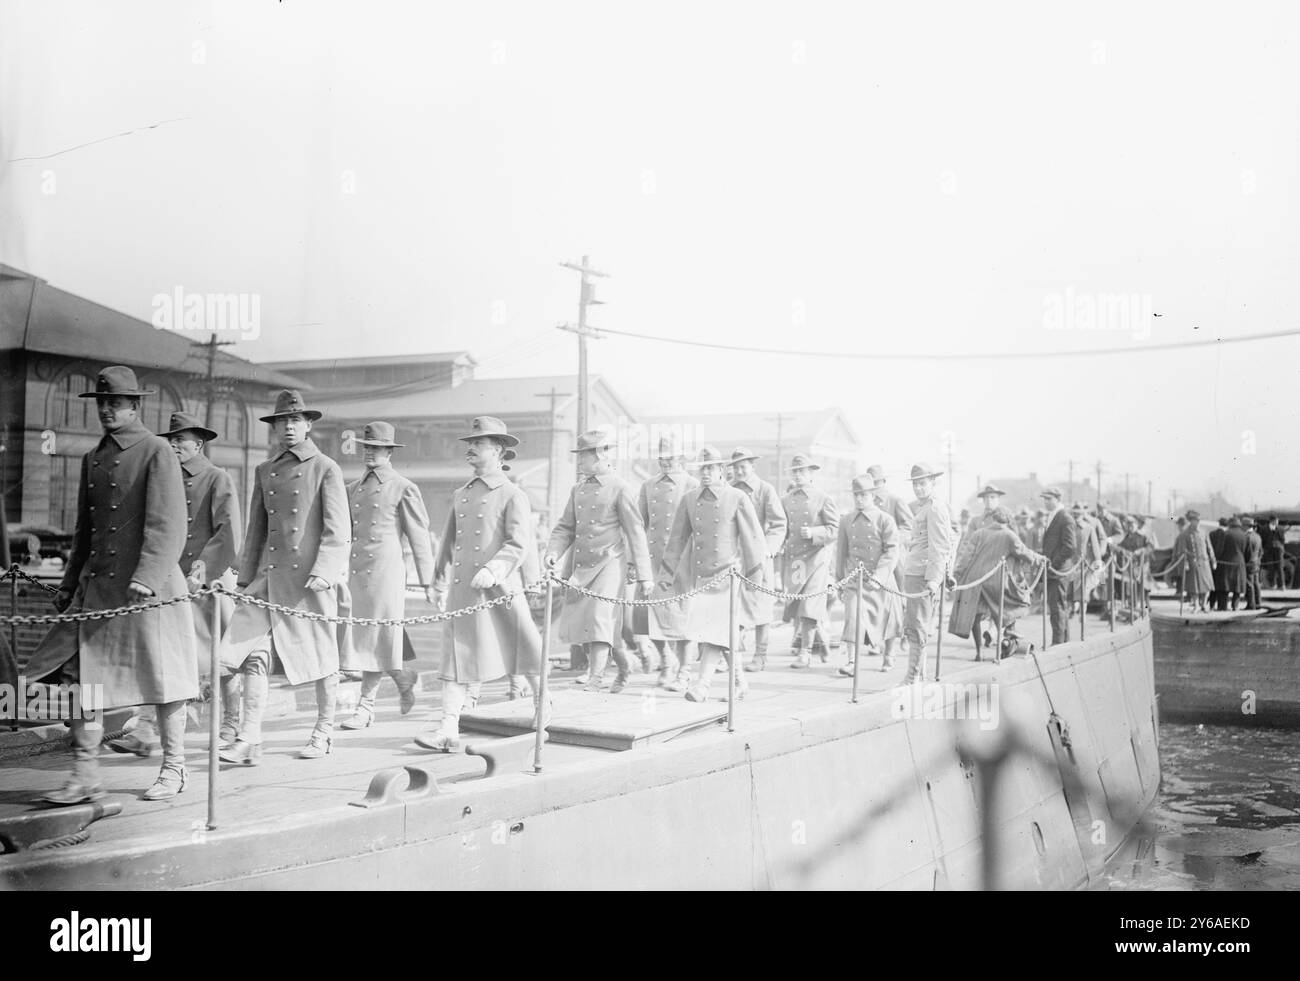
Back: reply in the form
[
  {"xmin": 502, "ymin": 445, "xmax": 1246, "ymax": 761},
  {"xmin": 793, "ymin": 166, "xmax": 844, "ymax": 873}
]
[{"xmin": 781, "ymin": 453, "xmax": 840, "ymax": 668}]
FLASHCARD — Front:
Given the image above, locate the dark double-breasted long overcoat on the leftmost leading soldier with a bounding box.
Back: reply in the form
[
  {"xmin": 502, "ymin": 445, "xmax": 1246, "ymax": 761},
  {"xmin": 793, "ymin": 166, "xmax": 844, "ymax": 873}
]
[{"xmin": 26, "ymin": 420, "xmax": 199, "ymax": 708}]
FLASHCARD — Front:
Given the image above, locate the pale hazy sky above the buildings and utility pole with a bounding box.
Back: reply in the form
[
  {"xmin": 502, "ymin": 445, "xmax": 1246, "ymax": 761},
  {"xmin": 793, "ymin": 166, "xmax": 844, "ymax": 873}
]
[{"xmin": 0, "ymin": 0, "xmax": 1300, "ymax": 508}]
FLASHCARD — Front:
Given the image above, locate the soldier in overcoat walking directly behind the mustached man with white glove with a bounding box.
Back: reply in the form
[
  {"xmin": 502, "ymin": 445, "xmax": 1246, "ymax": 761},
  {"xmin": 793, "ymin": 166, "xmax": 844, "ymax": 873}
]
[{"xmin": 546, "ymin": 430, "xmax": 654, "ymax": 693}]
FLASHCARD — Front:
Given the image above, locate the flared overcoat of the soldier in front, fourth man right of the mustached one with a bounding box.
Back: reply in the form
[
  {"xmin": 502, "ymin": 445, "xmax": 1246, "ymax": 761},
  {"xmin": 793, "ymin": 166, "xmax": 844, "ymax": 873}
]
[{"xmin": 663, "ymin": 483, "xmax": 767, "ymax": 648}]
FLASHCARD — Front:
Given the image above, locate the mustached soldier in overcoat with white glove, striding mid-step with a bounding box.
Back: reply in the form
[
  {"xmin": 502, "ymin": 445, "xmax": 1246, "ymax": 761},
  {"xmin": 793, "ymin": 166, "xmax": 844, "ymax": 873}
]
[{"xmin": 416, "ymin": 416, "xmax": 545, "ymax": 752}]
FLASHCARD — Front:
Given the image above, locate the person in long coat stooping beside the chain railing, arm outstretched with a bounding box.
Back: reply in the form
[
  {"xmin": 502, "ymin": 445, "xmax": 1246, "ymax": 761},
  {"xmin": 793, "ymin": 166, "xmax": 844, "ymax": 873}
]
[{"xmin": 948, "ymin": 505, "xmax": 1043, "ymax": 660}]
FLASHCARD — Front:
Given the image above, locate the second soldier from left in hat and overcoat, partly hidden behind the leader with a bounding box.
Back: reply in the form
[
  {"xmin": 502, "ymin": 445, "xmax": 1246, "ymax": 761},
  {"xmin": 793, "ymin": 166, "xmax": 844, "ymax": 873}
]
[{"xmin": 108, "ymin": 412, "xmax": 243, "ymax": 756}]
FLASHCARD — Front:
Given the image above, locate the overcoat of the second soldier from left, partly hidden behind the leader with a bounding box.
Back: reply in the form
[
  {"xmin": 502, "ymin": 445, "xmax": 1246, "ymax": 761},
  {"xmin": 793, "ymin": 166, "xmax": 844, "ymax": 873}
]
[{"xmin": 181, "ymin": 453, "xmax": 243, "ymax": 662}]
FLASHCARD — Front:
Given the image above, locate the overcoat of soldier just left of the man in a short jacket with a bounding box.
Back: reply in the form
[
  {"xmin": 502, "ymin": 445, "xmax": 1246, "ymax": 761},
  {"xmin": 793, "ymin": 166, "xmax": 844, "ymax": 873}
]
[{"xmin": 835, "ymin": 507, "xmax": 902, "ymax": 648}]
